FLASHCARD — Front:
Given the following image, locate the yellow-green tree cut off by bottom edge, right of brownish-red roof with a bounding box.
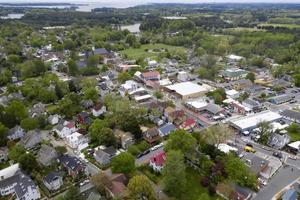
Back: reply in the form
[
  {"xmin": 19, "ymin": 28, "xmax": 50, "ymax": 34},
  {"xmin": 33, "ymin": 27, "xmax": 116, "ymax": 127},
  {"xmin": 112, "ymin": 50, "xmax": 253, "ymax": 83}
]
[{"xmin": 125, "ymin": 175, "xmax": 156, "ymax": 200}]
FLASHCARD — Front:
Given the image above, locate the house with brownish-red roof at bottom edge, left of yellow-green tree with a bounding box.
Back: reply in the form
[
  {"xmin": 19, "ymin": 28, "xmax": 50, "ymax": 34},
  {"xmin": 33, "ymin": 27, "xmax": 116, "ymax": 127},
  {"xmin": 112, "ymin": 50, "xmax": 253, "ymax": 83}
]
[{"xmin": 106, "ymin": 173, "xmax": 128, "ymax": 198}]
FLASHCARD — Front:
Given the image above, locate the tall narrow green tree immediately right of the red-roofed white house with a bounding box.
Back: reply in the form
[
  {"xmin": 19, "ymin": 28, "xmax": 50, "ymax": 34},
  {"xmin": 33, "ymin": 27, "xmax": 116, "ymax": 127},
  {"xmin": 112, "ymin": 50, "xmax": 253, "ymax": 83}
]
[{"xmin": 162, "ymin": 150, "xmax": 186, "ymax": 198}]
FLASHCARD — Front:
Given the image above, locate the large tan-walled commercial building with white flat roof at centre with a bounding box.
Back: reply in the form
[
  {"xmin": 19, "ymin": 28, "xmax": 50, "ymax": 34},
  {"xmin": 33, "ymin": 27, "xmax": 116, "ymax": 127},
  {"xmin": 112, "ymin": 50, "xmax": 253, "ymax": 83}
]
[{"xmin": 164, "ymin": 81, "xmax": 211, "ymax": 100}]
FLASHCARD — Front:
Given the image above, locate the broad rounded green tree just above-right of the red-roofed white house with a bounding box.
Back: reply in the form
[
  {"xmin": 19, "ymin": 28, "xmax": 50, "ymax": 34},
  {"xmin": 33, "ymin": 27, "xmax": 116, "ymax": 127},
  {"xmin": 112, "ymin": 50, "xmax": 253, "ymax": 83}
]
[{"xmin": 165, "ymin": 130, "xmax": 197, "ymax": 155}]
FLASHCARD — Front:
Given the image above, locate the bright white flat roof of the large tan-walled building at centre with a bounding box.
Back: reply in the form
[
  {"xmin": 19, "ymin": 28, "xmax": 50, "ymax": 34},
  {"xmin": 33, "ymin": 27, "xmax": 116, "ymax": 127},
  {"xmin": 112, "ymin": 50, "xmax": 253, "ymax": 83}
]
[{"xmin": 166, "ymin": 82, "xmax": 209, "ymax": 96}]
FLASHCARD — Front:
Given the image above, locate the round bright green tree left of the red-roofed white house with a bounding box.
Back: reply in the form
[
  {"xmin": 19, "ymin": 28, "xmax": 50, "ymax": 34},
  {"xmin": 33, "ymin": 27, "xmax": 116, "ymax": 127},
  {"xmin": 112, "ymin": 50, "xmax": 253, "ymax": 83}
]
[{"xmin": 111, "ymin": 152, "xmax": 135, "ymax": 176}]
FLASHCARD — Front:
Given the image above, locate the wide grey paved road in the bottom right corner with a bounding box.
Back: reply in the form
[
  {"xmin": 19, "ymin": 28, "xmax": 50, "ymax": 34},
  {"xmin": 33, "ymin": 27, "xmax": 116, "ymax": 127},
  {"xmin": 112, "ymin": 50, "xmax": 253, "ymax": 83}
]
[{"xmin": 254, "ymin": 166, "xmax": 300, "ymax": 200}]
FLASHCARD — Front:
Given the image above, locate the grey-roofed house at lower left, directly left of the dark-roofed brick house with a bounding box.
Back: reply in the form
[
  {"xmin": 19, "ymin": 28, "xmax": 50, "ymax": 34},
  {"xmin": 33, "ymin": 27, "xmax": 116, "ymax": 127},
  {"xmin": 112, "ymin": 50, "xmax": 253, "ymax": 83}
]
[{"xmin": 37, "ymin": 144, "xmax": 58, "ymax": 166}]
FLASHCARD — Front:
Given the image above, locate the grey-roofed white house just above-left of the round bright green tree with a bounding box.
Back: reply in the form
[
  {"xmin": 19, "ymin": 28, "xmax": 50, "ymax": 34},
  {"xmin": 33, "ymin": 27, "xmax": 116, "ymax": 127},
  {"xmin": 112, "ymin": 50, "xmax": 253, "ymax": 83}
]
[{"xmin": 94, "ymin": 146, "xmax": 117, "ymax": 165}]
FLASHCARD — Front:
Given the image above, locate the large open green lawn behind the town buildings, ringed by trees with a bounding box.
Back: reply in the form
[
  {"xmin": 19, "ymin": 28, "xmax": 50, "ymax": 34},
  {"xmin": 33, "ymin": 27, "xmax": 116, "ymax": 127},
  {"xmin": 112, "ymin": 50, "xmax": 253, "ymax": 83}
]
[{"xmin": 121, "ymin": 44, "xmax": 186, "ymax": 60}]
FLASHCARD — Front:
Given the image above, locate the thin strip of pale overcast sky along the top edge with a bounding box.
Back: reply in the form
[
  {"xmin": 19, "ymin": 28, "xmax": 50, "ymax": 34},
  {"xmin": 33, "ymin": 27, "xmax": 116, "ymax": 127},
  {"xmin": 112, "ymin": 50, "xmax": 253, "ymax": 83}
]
[{"xmin": 0, "ymin": 0, "xmax": 300, "ymax": 4}]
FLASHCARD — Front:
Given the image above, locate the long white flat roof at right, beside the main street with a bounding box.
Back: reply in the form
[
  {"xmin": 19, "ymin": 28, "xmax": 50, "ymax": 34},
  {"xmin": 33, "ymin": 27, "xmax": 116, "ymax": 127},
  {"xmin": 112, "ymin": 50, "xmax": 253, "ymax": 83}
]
[{"xmin": 230, "ymin": 111, "xmax": 282, "ymax": 130}]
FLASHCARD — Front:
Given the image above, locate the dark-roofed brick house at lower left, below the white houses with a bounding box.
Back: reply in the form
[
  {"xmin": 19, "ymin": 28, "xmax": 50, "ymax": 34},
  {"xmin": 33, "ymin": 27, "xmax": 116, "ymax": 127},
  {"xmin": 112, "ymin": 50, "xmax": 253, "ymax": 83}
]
[{"xmin": 58, "ymin": 154, "xmax": 85, "ymax": 178}]
